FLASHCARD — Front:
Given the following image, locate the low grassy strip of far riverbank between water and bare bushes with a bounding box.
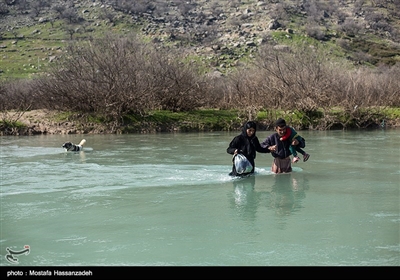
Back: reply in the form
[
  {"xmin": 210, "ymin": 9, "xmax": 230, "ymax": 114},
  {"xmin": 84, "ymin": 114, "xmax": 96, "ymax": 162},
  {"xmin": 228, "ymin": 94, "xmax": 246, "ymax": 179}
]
[{"xmin": 0, "ymin": 106, "xmax": 400, "ymax": 135}]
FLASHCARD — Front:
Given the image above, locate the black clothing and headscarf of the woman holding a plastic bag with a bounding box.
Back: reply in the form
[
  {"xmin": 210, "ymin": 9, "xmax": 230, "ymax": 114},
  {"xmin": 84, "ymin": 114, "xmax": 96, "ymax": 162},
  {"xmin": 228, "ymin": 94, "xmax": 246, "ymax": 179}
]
[{"xmin": 226, "ymin": 123, "xmax": 270, "ymax": 175}]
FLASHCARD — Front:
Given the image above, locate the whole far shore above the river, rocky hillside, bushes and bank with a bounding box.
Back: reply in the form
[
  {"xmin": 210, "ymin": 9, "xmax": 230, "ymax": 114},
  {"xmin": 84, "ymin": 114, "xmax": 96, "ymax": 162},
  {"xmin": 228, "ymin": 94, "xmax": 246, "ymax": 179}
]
[{"xmin": 0, "ymin": 0, "xmax": 400, "ymax": 135}]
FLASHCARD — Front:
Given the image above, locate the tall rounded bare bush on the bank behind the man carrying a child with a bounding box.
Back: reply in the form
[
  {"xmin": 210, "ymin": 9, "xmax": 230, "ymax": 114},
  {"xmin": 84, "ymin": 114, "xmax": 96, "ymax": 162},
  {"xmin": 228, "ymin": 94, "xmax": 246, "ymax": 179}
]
[{"xmin": 254, "ymin": 45, "xmax": 350, "ymax": 129}]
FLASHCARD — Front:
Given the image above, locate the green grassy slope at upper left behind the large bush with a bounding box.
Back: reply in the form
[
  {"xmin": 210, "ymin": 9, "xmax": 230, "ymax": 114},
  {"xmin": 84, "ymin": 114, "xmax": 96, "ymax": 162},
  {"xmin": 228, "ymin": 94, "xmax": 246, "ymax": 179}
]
[{"xmin": 0, "ymin": 15, "xmax": 144, "ymax": 79}]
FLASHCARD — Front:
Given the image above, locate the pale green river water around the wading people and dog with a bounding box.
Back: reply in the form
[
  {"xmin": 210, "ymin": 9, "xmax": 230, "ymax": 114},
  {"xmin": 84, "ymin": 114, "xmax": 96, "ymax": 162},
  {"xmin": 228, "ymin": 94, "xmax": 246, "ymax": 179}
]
[{"xmin": 0, "ymin": 130, "xmax": 400, "ymax": 266}]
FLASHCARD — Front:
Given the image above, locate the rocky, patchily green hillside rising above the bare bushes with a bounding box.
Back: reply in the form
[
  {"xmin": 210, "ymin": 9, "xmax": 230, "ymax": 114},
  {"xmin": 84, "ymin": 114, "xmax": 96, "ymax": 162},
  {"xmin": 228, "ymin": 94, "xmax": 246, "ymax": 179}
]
[{"xmin": 0, "ymin": 0, "xmax": 400, "ymax": 79}]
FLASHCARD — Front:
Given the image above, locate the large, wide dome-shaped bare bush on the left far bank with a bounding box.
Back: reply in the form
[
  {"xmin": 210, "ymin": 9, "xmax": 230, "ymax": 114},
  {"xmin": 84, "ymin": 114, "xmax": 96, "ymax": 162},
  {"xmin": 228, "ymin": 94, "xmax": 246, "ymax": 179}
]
[{"xmin": 32, "ymin": 31, "xmax": 204, "ymax": 126}]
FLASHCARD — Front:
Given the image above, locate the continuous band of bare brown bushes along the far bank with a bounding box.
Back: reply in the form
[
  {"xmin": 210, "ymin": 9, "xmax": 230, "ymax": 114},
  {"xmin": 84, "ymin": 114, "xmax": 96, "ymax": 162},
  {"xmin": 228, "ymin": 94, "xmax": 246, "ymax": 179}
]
[{"xmin": 0, "ymin": 35, "xmax": 400, "ymax": 129}]
